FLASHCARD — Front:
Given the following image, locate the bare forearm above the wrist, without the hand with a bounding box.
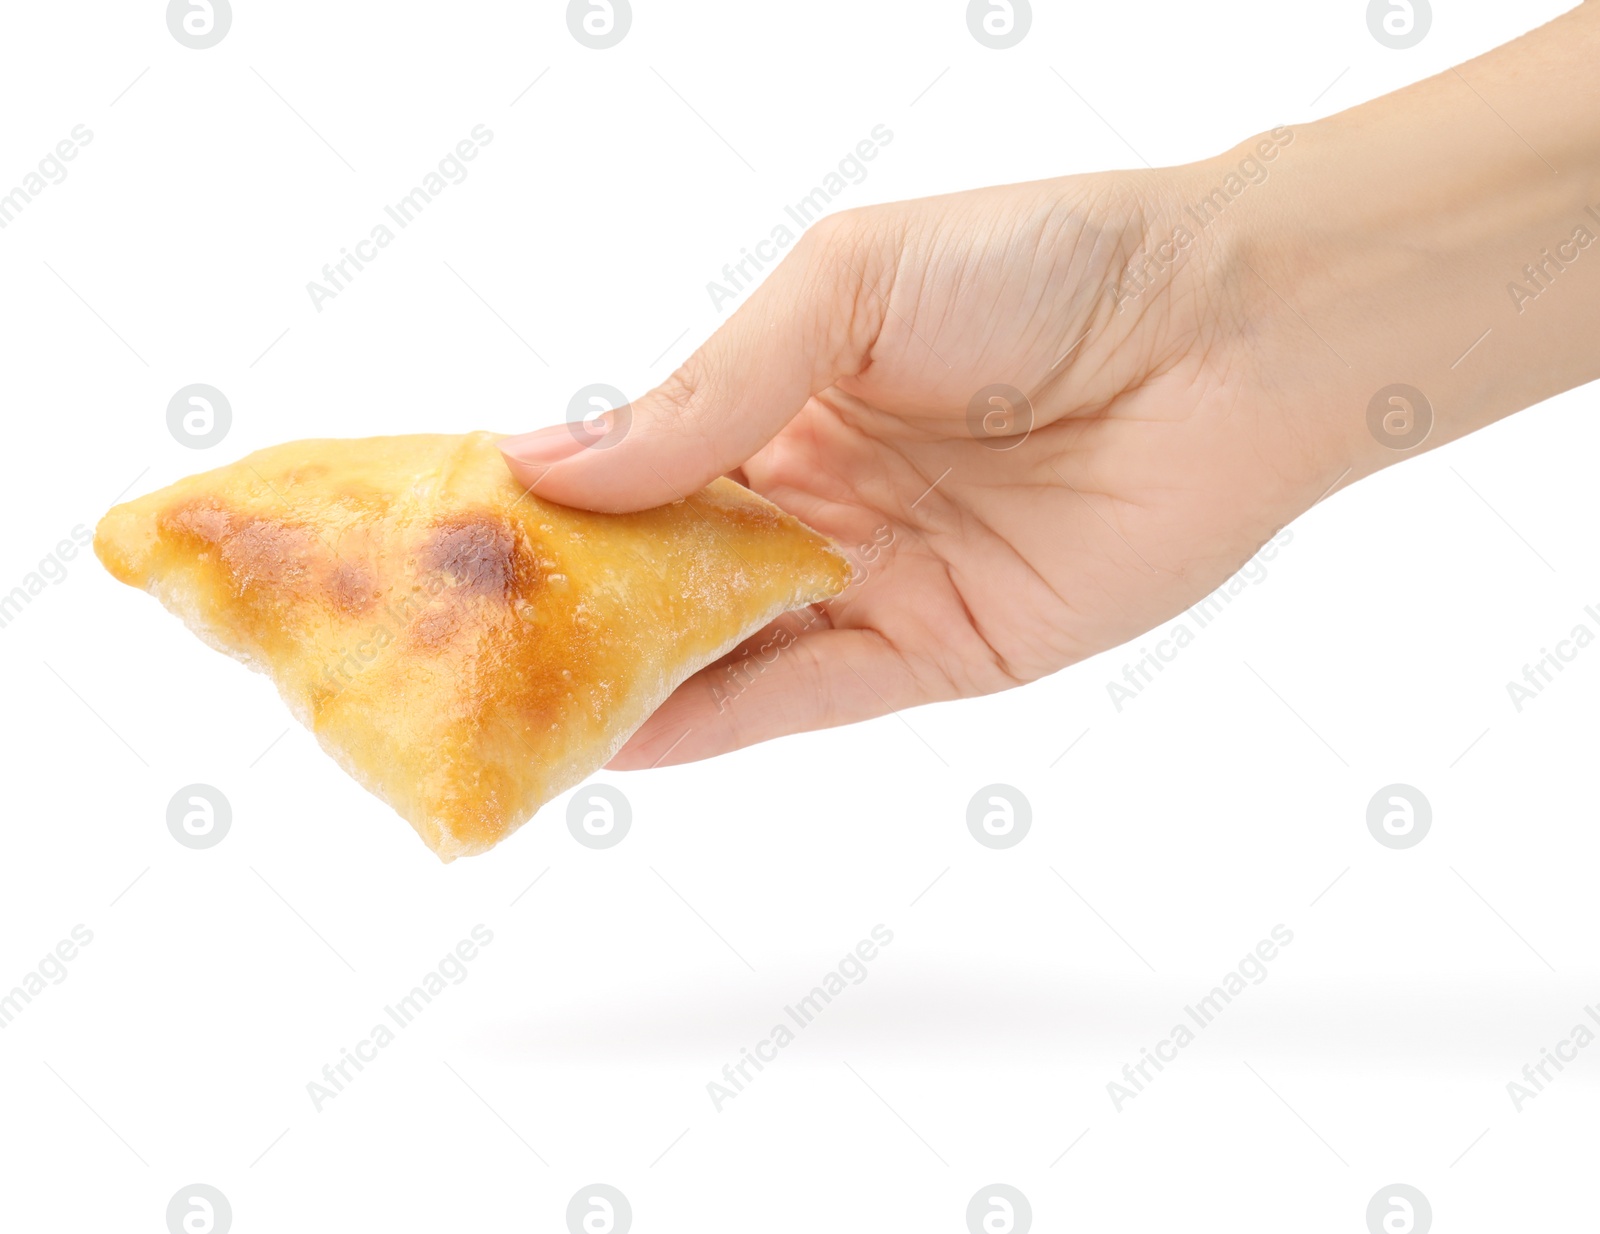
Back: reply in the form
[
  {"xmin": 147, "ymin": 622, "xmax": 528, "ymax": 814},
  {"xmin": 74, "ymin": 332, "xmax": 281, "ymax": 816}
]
[{"xmin": 1209, "ymin": 3, "xmax": 1600, "ymax": 474}]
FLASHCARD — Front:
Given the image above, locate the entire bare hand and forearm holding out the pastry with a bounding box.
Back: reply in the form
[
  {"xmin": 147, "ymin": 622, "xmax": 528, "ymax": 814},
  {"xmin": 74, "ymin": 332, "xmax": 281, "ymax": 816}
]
[{"xmin": 502, "ymin": 5, "xmax": 1600, "ymax": 768}]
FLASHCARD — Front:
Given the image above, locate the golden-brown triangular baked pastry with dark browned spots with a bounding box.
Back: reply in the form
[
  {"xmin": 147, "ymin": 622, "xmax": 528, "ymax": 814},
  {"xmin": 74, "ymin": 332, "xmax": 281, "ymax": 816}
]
[{"xmin": 94, "ymin": 432, "xmax": 850, "ymax": 861}]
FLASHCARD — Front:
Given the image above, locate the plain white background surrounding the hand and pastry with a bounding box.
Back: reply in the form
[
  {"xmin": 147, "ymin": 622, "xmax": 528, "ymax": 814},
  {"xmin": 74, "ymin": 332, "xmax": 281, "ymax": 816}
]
[{"xmin": 0, "ymin": 0, "xmax": 1600, "ymax": 1234}]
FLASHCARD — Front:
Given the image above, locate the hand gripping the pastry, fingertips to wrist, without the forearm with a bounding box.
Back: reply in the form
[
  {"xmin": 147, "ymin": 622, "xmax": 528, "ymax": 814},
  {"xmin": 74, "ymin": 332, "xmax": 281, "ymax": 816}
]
[{"xmin": 504, "ymin": 173, "xmax": 1339, "ymax": 767}]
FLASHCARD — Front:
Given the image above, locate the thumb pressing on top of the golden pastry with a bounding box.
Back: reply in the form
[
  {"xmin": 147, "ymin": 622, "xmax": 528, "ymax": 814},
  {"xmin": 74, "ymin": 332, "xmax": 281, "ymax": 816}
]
[{"xmin": 499, "ymin": 214, "xmax": 882, "ymax": 512}]
